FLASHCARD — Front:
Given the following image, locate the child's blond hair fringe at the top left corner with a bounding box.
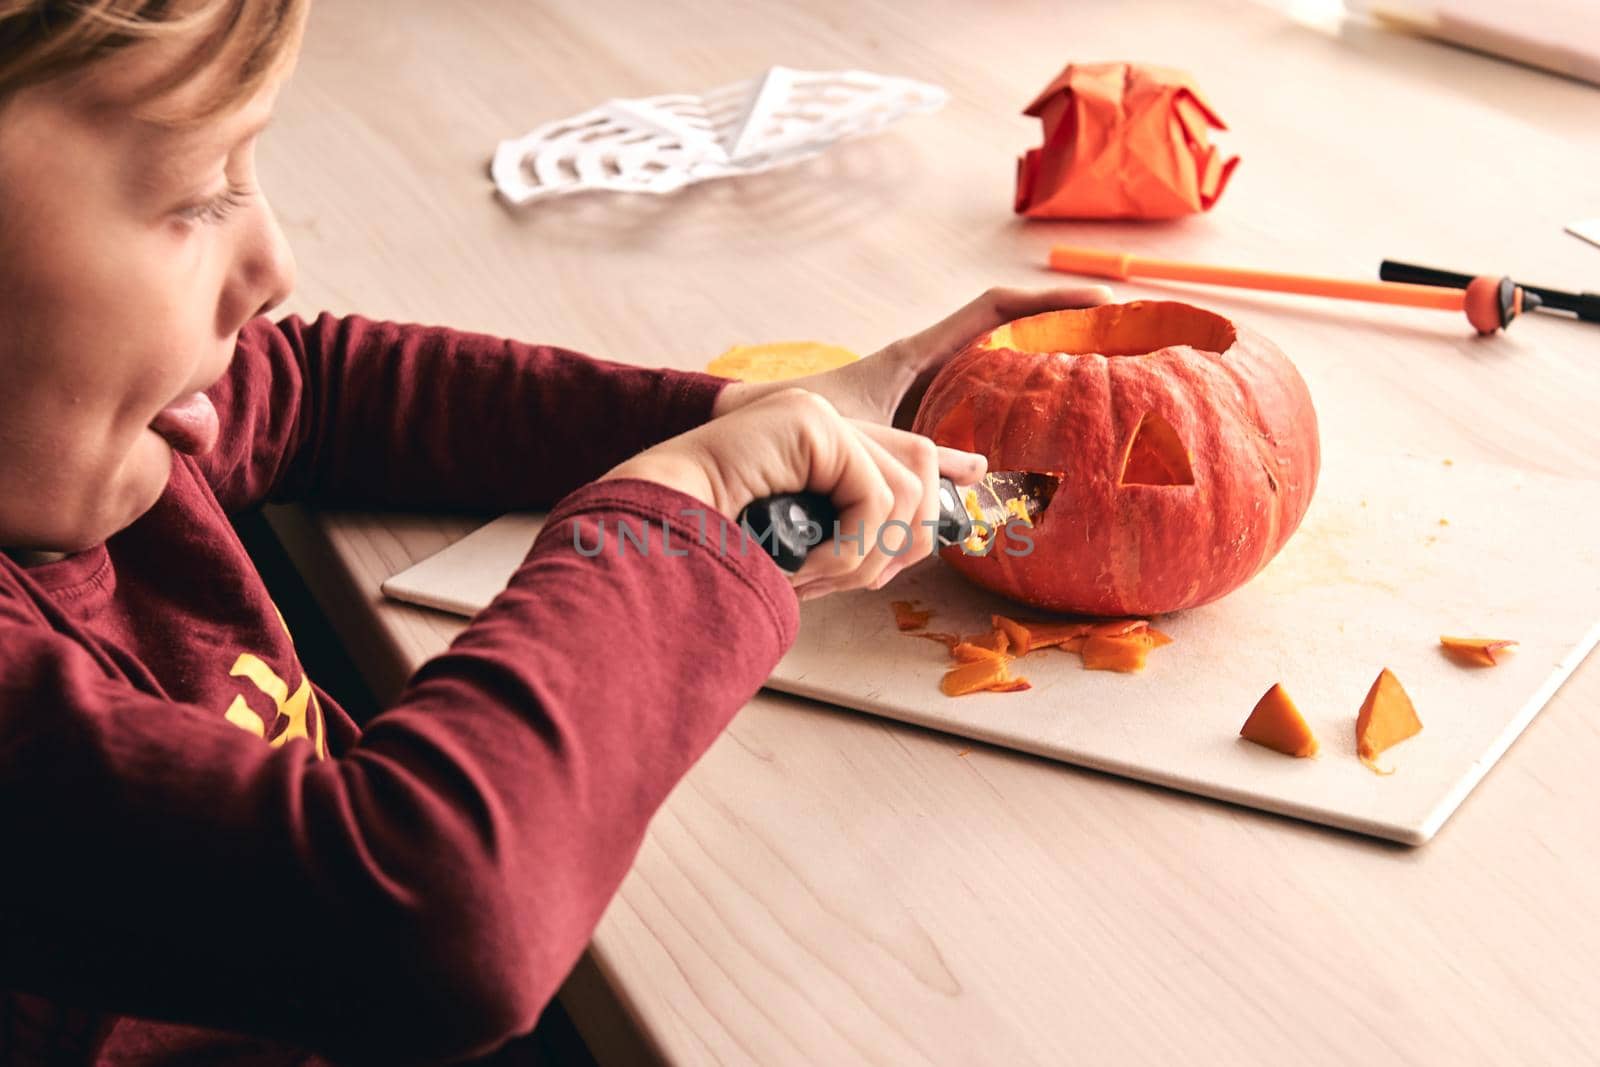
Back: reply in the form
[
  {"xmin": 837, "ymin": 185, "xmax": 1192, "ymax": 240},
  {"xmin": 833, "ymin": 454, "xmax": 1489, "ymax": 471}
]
[{"xmin": 0, "ymin": 0, "xmax": 309, "ymax": 122}]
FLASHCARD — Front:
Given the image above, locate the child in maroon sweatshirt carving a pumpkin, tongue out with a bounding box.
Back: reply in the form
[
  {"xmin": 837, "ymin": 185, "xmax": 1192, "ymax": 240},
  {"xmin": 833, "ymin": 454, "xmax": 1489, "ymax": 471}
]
[{"xmin": 0, "ymin": 0, "xmax": 1104, "ymax": 1064}]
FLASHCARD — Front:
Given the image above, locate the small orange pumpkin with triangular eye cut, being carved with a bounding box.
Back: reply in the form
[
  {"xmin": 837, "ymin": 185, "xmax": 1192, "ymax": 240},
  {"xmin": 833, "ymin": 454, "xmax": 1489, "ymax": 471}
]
[{"xmin": 915, "ymin": 301, "xmax": 1320, "ymax": 616}]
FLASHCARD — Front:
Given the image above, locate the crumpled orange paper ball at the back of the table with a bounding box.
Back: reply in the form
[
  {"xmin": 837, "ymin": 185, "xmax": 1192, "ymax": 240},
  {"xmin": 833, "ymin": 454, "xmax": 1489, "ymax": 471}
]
[{"xmin": 1016, "ymin": 62, "xmax": 1238, "ymax": 219}]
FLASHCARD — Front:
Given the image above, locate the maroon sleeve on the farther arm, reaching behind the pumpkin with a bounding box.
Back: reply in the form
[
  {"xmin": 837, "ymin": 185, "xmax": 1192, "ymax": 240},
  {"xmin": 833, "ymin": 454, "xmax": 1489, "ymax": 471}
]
[{"xmin": 202, "ymin": 314, "xmax": 726, "ymax": 512}]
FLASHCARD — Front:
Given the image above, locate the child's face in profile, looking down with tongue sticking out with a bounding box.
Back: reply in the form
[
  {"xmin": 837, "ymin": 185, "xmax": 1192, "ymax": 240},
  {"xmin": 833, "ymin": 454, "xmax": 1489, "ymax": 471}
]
[{"xmin": 0, "ymin": 30, "xmax": 294, "ymax": 552}]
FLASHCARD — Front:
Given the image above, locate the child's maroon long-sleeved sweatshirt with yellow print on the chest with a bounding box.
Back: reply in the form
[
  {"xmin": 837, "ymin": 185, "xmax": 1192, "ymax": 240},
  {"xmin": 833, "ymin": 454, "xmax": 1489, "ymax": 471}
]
[{"xmin": 0, "ymin": 315, "xmax": 798, "ymax": 1064}]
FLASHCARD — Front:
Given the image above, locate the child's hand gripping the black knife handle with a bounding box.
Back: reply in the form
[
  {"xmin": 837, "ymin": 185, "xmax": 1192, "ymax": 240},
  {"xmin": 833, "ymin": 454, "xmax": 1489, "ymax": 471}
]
[{"xmin": 602, "ymin": 389, "xmax": 987, "ymax": 597}]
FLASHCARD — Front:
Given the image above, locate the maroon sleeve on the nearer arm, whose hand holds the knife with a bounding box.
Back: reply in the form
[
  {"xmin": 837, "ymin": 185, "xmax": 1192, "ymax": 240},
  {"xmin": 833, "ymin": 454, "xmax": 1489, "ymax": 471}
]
[{"xmin": 0, "ymin": 479, "xmax": 798, "ymax": 1064}]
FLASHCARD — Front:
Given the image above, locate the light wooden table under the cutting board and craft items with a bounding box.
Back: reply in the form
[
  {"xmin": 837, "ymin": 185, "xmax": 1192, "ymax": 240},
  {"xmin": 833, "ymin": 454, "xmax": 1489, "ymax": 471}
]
[{"xmin": 262, "ymin": 0, "xmax": 1600, "ymax": 1064}]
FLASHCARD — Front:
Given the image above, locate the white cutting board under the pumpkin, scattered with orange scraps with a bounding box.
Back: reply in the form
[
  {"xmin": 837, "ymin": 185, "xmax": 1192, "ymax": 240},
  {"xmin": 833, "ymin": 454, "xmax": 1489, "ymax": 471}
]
[{"xmin": 384, "ymin": 456, "xmax": 1600, "ymax": 845}]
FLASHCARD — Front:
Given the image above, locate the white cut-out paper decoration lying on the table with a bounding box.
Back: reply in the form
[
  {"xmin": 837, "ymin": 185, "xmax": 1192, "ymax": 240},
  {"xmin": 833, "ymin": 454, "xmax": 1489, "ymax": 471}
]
[{"xmin": 491, "ymin": 67, "xmax": 947, "ymax": 205}]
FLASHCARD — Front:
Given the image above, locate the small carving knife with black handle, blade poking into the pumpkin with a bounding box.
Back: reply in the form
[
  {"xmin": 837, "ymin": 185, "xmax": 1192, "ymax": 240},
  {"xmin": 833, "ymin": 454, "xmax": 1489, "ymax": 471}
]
[{"xmin": 739, "ymin": 470, "xmax": 1061, "ymax": 574}]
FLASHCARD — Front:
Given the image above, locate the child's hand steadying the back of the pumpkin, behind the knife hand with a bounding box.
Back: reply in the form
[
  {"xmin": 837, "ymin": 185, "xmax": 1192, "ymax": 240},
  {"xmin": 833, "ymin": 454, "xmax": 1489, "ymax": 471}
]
[{"xmin": 712, "ymin": 285, "xmax": 1110, "ymax": 429}]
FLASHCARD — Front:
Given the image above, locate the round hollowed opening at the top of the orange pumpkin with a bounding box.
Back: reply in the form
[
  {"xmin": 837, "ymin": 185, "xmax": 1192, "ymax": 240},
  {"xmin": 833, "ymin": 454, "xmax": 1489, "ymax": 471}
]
[{"xmin": 982, "ymin": 301, "xmax": 1235, "ymax": 355}]
